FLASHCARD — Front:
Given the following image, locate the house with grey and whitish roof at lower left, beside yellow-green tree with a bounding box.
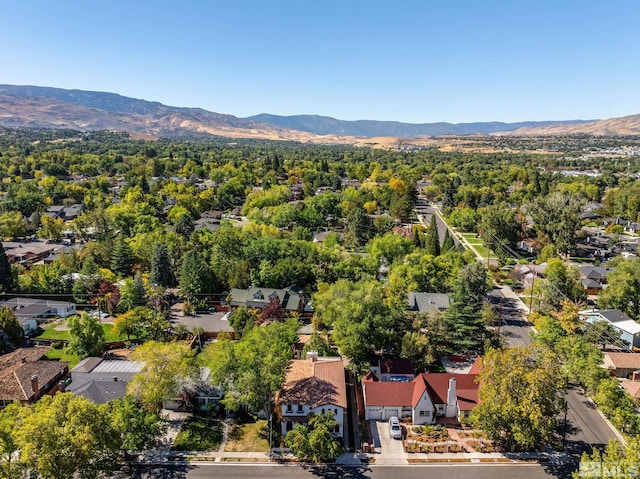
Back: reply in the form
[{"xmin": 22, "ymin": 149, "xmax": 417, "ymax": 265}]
[{"xmin": 67, "ymin": 357, "xmax": 144, "ymax": 404}]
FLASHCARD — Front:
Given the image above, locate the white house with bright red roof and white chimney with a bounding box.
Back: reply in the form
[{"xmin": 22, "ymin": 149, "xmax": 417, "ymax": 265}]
[{"xmin": 362, "ymin": 373, "xmax": 479, "ymax": 424}]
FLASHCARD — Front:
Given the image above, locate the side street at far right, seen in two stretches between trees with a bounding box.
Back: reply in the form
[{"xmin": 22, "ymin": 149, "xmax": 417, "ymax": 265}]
[{"xmin": 489, "ymin": 286, "xmax": 617, "ymax": 456}]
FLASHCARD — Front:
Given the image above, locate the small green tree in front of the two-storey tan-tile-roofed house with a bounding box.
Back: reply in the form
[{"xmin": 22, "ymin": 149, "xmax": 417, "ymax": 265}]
[{"xmin": 284, "ymin": 412, "xmax": 344, "ymax": 462}]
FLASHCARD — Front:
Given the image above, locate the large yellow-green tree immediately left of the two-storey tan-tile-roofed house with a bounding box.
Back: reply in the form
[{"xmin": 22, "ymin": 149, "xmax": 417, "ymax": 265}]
[{"xmin": 203, "ymin": 319, "xmax": 298, "ymax": 417}]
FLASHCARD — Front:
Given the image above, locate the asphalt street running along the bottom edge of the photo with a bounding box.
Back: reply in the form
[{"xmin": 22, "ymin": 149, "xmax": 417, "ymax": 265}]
[{"xmin": 113, "ymin": 464, "xmax": 570, "ymax": 479}]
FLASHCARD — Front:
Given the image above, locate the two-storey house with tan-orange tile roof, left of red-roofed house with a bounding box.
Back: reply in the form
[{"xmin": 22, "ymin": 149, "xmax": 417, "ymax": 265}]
[{"xmin": 277, "ymin": 353, "xmax": 347, "ymax": 437}]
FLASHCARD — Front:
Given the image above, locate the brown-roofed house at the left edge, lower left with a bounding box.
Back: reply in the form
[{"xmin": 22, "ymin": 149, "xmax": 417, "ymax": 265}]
[{"xmin": 0, "ymin": 346, "xmax": 69, "ymax": 408}]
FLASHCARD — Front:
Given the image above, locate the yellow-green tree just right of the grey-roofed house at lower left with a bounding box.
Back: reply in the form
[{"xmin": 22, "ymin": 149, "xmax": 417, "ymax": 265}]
[{"xmin": 127, "ymin": 341, "xmax": 200, "ymax": 411}]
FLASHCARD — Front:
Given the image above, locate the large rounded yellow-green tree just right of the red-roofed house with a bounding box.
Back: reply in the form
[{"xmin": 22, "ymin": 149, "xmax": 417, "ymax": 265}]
[{"xmin": 471, "ymin": 346, "xmax": 563, "ymax": 450}]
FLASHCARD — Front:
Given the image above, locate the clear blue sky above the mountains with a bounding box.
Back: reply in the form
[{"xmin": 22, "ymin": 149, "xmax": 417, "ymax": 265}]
[{"xmin": 0, "ymin": 0, "xmax": 640, "ymax": 123}]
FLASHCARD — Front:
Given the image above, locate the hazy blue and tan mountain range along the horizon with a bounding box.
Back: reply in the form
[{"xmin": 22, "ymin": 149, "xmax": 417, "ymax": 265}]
[{"xmin": 0, "ymin": 85, "xmax": 640, "ymax": 143}]
